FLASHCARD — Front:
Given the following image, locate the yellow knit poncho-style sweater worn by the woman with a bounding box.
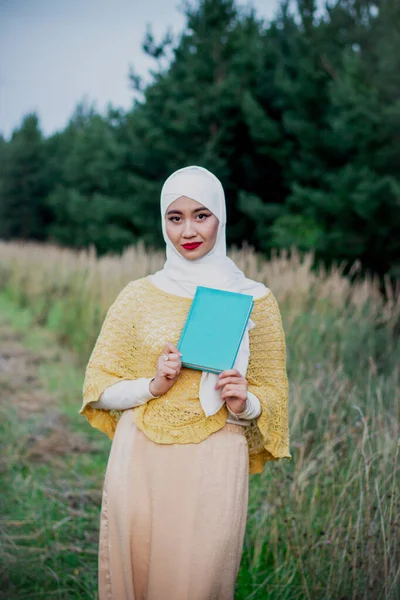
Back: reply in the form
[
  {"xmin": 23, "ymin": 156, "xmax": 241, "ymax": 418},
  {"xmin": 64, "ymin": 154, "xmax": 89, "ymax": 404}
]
[{"xmin": 79, "ymin": 277, "xmax": 291, "ymax": 473}]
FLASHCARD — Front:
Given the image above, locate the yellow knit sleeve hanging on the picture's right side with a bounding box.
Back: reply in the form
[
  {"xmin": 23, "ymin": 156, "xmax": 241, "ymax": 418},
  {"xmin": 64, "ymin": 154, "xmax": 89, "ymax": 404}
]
[{"xmin": 246, "ymin": 290, "xmax": 291, "ymax": 472}]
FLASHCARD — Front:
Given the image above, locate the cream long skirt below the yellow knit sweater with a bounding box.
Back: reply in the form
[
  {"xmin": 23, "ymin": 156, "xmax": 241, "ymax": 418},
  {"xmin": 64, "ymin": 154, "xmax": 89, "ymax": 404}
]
[{"xmin": 99, "ymin": 410, "xmax": 248, "ymax": 600}]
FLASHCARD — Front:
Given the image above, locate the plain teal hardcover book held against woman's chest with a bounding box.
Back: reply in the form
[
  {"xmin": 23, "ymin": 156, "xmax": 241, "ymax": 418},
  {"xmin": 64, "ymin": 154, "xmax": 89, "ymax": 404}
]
[{"xmin": 178, "ymin": 286, "xmax": 254, "ymax": 373}]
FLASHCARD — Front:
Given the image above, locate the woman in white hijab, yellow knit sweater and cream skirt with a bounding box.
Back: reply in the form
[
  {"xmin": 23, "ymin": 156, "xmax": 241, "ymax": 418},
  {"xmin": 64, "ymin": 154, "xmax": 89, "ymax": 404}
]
[{"xmin": 80, "ymin": 166, "xmax": 290, "ymax": 600}]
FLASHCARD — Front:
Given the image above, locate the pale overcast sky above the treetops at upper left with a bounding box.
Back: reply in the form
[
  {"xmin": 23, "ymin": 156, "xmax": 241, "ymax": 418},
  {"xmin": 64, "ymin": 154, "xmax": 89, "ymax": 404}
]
[{"xmin": 0, "ymin": 0, "xmax": 278, "ymax": 139}]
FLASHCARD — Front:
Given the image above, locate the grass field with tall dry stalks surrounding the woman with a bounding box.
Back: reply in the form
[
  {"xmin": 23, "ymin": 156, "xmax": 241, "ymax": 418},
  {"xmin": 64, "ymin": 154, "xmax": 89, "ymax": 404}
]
[{"xmin": 0, "ymin": 243, "xmax": 400, "ymax": 600}]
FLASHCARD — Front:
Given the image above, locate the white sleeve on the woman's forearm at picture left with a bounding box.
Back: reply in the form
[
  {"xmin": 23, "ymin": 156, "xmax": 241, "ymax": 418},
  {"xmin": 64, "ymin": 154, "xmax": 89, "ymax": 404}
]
[{"xmin": 89, "ymin": 377, "xmax": 158, "ymax": 410}]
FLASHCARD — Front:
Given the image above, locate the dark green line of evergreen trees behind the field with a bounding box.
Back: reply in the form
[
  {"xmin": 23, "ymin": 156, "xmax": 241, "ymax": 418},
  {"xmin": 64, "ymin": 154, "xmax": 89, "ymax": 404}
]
[{"xmin": 0, "ymin": 0, "xmax": 400, "ymax": 277}]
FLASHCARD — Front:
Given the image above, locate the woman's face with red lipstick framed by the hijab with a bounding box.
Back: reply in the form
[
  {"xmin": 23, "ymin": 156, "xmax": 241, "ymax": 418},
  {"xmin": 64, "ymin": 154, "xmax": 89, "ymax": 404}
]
[{"xmin": 165, "ymin": 196, "xmax": 219, "ymax": 260}]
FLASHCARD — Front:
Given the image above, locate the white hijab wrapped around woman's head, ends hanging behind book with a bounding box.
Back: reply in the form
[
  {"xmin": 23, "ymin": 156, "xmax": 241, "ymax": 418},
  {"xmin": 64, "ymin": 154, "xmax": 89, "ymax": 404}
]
[{"xmin": 151, "ymin": 166, "xmax": 268, "ymax": 417}]
